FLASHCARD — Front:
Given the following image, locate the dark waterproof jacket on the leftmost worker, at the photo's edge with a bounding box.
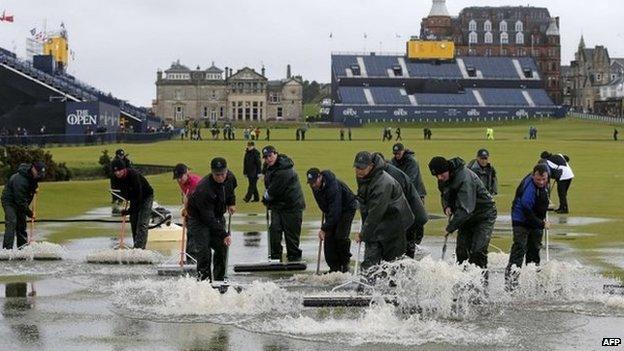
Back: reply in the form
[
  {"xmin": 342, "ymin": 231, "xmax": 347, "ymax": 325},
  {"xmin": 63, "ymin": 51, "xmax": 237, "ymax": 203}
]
[{"xmin": 2, "ymin": 163, "xmax": 39, "ymax": 217}]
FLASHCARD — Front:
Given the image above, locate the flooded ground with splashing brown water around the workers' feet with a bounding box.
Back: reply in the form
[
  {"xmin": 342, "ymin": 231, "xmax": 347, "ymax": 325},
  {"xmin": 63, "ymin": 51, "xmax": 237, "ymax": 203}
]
[{"xmin": 0, "ymin": 215, "xmax": 624, "ymax": 351}]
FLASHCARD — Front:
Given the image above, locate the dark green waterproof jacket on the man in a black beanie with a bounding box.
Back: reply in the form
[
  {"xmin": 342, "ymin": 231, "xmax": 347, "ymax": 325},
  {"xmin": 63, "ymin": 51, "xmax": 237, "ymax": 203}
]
[{"xmin": 438, "ymin": 157, "xmax": 496, "ymax": 233}]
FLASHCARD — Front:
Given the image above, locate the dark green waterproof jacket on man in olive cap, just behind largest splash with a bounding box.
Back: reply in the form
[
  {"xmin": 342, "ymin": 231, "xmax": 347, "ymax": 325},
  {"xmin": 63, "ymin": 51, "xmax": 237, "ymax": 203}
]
[{"xmin": 357, "ymin": 160, "xmax": 414, "ymax": 247}]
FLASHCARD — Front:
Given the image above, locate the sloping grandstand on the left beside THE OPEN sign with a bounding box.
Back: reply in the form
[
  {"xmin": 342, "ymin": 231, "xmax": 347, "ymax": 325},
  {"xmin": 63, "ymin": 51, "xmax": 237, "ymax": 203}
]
[{"xmin": 0, "ymin": 48, "xmax": 162, "ymax": 140}]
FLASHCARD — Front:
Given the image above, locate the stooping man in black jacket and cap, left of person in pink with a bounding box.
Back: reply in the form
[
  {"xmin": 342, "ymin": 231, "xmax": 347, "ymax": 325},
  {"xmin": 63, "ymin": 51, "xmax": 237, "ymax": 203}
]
[{"xmin": 111, "ymin": 158, "xmax": 154, "ymax": 249}]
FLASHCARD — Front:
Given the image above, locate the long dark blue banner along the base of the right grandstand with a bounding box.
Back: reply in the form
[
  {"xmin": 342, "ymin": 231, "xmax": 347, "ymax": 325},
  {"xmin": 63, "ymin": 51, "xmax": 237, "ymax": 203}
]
[{"xmin": 332, "ymin": 105, "xmax": 565, "ymax": 125}]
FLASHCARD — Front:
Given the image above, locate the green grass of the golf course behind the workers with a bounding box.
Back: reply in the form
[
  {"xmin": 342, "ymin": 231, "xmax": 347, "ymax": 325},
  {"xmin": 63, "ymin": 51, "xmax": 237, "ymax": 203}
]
[{"xmin": 1, "ymin": 119, "xmax": 624, "ymax": 276}]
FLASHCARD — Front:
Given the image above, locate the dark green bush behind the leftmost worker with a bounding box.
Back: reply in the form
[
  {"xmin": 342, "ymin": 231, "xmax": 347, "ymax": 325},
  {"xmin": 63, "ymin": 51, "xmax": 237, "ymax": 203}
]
[{"xmin": 0, "ymin": 146, "xmax": 72, "ymax": 184}]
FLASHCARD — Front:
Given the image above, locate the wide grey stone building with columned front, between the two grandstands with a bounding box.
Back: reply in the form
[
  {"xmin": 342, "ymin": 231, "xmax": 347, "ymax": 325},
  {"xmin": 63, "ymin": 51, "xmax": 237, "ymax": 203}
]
[{"xmin": 152, "ymin": 61, "xmax": 303, "ymax": 122}]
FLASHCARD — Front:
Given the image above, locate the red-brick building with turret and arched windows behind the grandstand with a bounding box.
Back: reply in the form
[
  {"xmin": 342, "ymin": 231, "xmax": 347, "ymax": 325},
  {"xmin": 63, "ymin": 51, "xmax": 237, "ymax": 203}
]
[{"xmin": 420, "ymin": 0, "xmax": 562, "ymax": 103}]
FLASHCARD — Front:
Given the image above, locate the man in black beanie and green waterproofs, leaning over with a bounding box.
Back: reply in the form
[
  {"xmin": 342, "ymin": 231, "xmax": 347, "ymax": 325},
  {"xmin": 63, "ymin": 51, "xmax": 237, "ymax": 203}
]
[{"xmin": 429, "ymin": 156, "xmax": 496, "ymax": 274}]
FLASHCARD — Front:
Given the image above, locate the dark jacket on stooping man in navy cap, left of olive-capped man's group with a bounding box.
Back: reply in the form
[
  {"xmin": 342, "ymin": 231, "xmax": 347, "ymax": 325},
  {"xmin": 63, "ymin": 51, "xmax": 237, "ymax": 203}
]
[{"xmin": 312, "ymin": 171, "xmax": 357, "ymax": 231}]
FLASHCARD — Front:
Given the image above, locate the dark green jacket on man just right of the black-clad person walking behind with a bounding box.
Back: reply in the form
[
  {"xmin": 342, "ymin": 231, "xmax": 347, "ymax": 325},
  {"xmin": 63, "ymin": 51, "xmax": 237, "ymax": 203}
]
[{"xmin": 262, "ymin": 154, "xmax": 305, "ymax": 211}]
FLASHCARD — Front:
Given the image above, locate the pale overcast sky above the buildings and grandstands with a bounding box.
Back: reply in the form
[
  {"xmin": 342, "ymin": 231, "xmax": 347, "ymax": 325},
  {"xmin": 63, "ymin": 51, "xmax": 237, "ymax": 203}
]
[{"xmin": 0, "ymin": 0, "xmax": 624, "ymax": 106}]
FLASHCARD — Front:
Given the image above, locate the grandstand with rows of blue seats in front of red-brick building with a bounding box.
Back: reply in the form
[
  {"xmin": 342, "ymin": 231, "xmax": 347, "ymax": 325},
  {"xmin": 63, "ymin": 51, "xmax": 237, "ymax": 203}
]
[{"xmin": 330, "ymin": 53, "xmax": 565, "ymax": 125}]
